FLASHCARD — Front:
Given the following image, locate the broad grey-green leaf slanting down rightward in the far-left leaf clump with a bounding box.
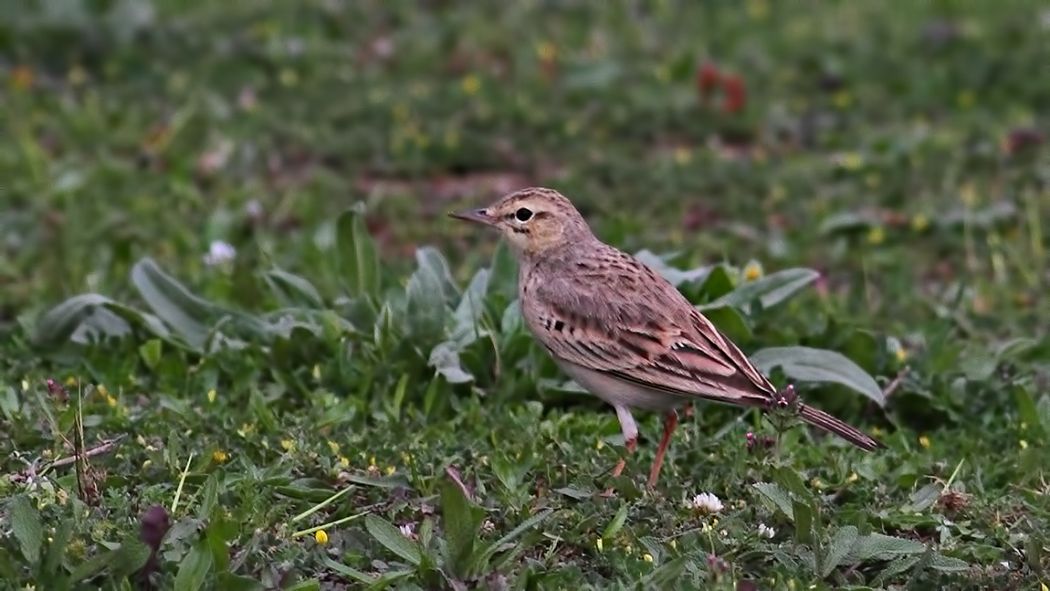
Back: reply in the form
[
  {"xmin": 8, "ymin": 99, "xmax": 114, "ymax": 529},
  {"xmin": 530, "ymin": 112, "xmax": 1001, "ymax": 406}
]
[{"xmin": 131, "ymin": 258, "xmax": 217, "ymax": 351}]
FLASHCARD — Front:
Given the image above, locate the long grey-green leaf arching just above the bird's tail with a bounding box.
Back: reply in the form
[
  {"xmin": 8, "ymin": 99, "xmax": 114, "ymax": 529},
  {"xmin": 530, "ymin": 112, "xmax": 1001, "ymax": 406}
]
[{"xmin": 751, "ymin": 346, "xmax": 886, "ymax": 406}]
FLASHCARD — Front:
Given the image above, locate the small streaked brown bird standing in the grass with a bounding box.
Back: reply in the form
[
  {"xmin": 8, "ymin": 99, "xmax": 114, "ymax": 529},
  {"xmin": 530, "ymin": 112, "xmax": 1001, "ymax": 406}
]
[{"xmin": 449, "ymin": 187, "xmax": 884, "ymax": 489}]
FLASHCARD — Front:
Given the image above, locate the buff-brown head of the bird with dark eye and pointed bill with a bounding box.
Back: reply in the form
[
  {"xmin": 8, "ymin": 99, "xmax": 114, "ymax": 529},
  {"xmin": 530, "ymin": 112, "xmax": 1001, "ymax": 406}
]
[{"xmin": 449, "ymin": 187, "xmax": 593, "ymax": 256}]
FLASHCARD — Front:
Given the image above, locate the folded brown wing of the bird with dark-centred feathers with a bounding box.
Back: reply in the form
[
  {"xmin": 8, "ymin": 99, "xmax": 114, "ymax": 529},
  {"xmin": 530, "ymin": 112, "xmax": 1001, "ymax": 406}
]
[{"xmin": 523, "ymin": 252, "xmax": 776, "ymax": 406}]
